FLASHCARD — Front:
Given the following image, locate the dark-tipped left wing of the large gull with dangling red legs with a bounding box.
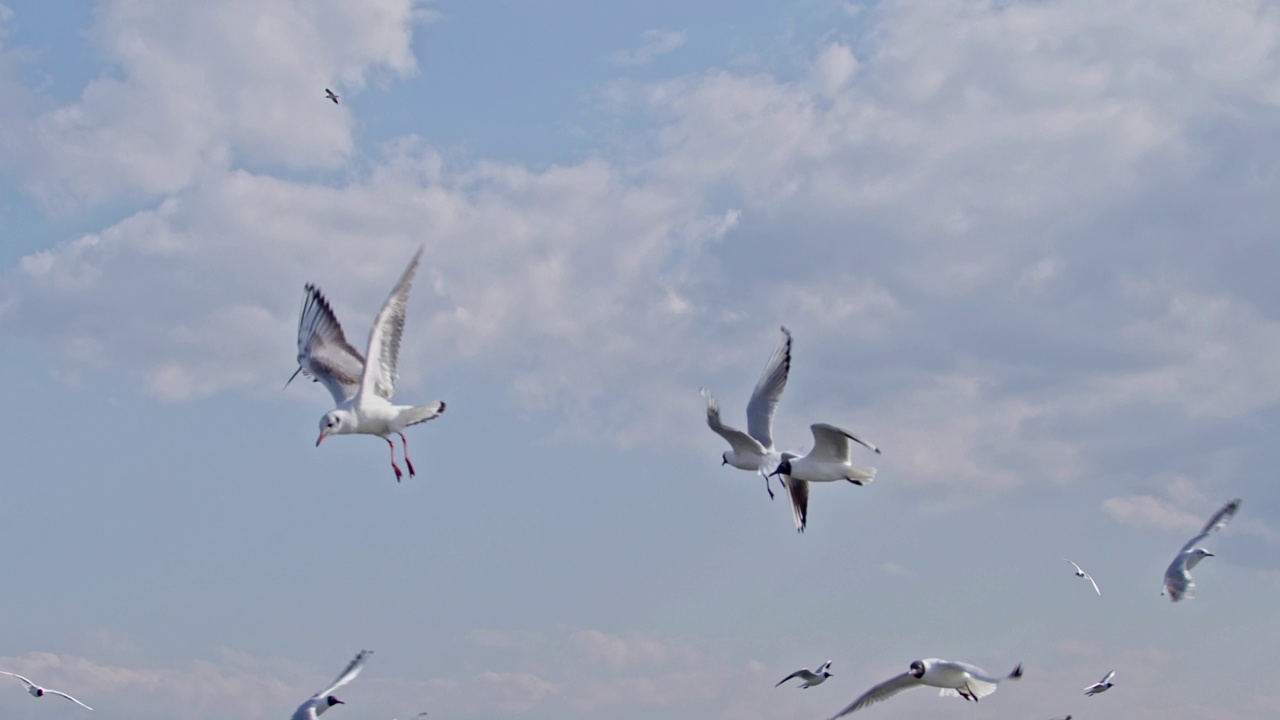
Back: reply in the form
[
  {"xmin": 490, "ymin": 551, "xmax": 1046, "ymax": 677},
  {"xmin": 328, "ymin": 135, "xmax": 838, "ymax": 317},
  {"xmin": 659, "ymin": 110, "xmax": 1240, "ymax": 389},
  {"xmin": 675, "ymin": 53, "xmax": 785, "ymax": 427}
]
[{"xmin": 298, "ymin": 283, "xmax": 365, "ymax": 405}]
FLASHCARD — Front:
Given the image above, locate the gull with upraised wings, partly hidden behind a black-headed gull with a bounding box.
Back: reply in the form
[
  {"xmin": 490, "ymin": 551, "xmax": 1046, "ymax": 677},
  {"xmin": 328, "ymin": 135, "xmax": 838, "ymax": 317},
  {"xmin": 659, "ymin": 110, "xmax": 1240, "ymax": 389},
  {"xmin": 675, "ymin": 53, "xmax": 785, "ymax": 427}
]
[{"xmin": 700, "ymin": 327, "xmax": 791, "ymax": 500}]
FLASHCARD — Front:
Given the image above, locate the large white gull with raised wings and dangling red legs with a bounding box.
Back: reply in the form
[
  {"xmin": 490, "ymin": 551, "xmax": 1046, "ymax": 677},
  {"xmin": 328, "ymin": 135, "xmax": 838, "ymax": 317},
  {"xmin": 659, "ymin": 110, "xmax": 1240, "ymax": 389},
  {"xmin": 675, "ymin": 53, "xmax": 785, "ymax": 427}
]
[{"xmin": 284, "ymin": 247, "xmax": 444, "ymax": 482}]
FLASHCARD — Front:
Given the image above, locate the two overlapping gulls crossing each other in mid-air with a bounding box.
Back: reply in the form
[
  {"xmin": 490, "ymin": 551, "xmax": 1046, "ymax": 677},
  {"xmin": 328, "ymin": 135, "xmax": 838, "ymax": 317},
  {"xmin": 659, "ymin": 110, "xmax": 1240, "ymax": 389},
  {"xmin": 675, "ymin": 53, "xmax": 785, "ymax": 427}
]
[{"xmin": 701, "ymin": 327, "xmax": 879, "ymax": 532}]
